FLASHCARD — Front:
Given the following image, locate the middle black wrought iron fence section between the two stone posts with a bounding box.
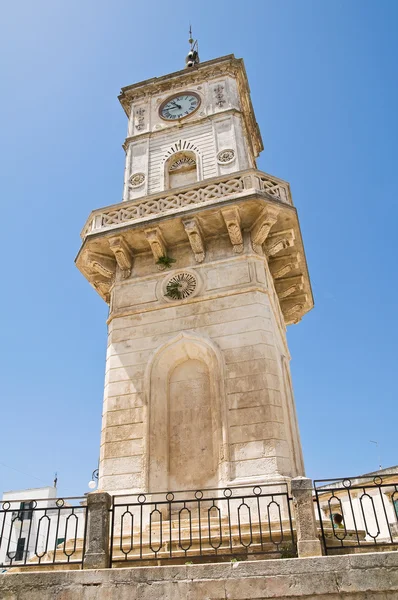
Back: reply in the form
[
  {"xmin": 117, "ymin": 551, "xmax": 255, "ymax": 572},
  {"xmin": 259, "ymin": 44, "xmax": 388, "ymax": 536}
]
[{"xmin": 111, "ymin": 484, "xmax": 296, "ymax": 564}]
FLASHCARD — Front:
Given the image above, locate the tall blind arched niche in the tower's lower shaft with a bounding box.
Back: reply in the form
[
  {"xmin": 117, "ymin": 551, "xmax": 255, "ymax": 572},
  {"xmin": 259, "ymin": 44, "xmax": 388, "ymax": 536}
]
[{"xmin": 146, "ymin": 332, "xmax": 229, "ymax": 492}]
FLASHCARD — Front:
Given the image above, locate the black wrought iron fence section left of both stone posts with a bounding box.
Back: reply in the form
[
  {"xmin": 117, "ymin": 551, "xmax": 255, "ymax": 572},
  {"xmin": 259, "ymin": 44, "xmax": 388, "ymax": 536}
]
[{"xmin": 0, "ymin": 498, "xmax": 87, "ymax": 569}]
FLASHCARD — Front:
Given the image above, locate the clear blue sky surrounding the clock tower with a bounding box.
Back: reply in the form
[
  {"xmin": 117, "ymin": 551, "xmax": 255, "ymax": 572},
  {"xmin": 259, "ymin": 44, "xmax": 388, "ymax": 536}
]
[{"xmin": 0, "ymin": 0, "xmax": 398, "ymax": 495}]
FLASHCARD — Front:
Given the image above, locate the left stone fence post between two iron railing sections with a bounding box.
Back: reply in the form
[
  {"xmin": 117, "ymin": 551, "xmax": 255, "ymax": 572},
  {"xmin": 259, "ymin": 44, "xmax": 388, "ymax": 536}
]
[{"xmin": 83, "ymin": 492, "xmax": 112, "ymax": 569}]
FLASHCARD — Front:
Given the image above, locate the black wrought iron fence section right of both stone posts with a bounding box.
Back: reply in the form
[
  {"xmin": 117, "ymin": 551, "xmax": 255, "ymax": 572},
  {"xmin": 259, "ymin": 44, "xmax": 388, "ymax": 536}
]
[{"xmin": 314, "ymin": 473, "xmax": 398, "ymax": 554}]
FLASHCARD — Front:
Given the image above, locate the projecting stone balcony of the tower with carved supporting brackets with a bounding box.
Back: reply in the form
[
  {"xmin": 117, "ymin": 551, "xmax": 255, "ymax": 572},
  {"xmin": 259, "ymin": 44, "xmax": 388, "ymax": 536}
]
[{"xmin": 76, "ymin": 169, "xmax": 313, "ymax": 326}]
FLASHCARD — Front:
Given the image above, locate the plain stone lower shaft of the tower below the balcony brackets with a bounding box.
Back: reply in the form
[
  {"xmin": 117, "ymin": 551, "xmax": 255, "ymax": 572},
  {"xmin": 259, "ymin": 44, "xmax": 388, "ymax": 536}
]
[{"xmin": 99, "ymin": 236, "xmax": 304, "ymax": 493}]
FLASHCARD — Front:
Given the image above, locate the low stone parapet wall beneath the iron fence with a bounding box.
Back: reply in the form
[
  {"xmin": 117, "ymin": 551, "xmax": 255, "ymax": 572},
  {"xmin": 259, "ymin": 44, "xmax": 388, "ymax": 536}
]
[{"xmin": 0, "ymin": 552, "xmax": 398, "ymax": 600}]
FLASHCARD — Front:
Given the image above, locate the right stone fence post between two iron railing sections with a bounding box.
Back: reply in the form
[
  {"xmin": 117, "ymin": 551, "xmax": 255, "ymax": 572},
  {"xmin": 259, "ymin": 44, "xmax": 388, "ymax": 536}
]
[{"xmin": 291, "ymin": 477, "xmax": 322, "ymax": 558}]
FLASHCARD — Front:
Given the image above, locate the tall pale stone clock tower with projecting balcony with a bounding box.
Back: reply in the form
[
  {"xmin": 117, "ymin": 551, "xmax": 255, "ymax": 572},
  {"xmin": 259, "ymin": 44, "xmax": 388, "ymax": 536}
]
[{"xmin": 76, "ymin": 55, "xmax": 313, "ymax": 493}]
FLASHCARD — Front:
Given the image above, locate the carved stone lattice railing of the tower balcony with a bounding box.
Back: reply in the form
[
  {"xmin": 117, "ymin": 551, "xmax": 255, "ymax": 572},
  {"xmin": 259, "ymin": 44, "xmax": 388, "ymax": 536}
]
[{"xmin": 81, "ymin": 169, "xmax": 292, "ymax": 239}]
